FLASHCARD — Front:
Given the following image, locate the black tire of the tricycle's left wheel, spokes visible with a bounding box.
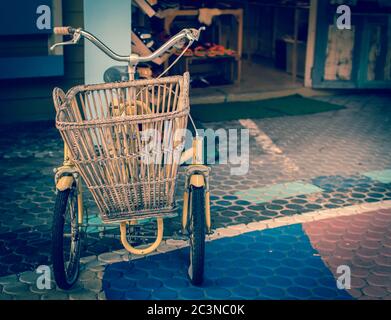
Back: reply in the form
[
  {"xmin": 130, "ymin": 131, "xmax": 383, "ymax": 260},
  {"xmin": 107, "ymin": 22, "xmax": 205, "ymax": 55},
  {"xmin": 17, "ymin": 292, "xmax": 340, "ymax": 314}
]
[{"xmin": 52, "ymin": 187, "xmax": 81, "ymax": 290}]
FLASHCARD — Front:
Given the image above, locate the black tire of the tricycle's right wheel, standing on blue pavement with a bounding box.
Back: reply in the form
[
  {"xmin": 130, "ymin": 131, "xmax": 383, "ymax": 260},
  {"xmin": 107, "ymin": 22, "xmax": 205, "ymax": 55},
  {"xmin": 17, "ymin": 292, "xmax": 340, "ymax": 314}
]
[{"xmin": 188, "ymin": 187, "xmax": 205, "ymax": 286}]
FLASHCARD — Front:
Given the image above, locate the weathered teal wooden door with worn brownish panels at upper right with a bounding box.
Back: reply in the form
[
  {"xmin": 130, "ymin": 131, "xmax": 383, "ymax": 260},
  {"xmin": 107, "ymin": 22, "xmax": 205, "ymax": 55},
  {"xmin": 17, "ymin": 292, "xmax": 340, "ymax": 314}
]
[{"xmin": 306, "ymin": 0, "xmax": 391, "ymax": 89}]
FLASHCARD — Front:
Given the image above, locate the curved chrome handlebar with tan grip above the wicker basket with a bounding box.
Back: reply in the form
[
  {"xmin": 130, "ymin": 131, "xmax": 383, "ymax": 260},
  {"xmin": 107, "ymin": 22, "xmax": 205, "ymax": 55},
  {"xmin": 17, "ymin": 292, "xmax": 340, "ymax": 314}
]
[{"xmin": 50, "ymin": 27, "xmax": 205, "ymax": 65}]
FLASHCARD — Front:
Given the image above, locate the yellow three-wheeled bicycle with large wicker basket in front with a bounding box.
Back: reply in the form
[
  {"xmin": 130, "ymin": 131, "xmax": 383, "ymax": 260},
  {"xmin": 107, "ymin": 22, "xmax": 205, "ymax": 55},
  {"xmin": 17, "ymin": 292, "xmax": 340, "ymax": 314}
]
[{"xmin": 51, "ymin": 27, "xmax": 211, "ymax": 289}]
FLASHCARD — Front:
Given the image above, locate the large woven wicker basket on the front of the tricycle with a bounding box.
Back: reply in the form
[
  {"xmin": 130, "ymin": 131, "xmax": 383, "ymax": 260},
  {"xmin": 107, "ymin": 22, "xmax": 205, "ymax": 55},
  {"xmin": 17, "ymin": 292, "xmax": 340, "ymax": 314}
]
[{"xmin": 56, "ymin": 73, "xmax": 189, "ymax": 222}]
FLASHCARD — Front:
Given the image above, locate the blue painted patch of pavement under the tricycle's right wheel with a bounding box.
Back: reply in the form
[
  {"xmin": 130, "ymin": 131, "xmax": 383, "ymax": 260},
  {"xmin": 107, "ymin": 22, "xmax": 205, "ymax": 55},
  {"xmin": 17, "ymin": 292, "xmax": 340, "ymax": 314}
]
[{"xmin": 103, "ymin": 225, "xmax": 351, "ymax": 300}]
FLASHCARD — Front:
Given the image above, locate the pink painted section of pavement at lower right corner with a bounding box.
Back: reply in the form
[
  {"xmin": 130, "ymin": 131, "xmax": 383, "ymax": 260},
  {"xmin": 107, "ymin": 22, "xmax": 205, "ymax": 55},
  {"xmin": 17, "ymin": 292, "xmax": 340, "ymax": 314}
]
[{"xmin": 303, "ymin": 209, "xmax": 391, "ymax": 300}]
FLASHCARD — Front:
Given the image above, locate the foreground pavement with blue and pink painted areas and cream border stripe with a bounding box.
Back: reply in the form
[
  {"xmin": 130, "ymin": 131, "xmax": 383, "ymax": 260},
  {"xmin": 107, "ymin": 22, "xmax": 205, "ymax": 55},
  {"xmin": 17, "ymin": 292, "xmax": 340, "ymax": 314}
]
[{"xmin": 0, "ymin": 201, "xmax": 391, "ymax": 300}]
